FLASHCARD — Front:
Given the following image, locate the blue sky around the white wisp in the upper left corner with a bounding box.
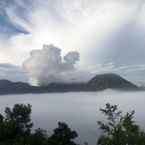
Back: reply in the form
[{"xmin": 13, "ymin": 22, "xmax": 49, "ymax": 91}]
[{"xmin": 0, "ymin": 0, "xmax": 29, "ymax": 37}]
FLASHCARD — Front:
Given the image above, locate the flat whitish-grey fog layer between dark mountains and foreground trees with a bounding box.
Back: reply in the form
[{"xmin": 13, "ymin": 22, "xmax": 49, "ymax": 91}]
[{"xmin": 0, "ymin": 90, "xmax": 145, "ymax": 145}]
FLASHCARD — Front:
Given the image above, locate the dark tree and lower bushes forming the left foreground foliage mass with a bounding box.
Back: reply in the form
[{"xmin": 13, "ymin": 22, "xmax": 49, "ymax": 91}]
[{"xmin": 0, "ymin": 104, "xmax": 77, "ymax": 145}]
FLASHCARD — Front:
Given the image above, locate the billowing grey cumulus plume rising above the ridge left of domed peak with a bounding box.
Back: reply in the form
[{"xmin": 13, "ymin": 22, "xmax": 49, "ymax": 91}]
[{"xmin": 23, "ymin": 45, "xmax": 80, "ymax": 85}]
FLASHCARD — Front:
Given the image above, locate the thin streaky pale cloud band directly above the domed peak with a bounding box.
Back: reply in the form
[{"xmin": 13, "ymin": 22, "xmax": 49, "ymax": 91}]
[{"xmin": 89, "ymin": 62, "xmax": 145, "ymax": 85}]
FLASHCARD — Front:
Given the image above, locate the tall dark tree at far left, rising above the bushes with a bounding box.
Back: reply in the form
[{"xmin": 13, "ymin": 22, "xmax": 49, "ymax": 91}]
[{"xmin": 0, "ymin": 104, "xmax": 33, "ymax": 145}]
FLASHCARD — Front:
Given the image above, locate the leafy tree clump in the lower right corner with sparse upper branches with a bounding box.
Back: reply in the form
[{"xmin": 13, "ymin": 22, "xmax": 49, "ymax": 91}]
[{"xmin": 97, "ymin": 104, "xmax": 145, "ymax": 145}]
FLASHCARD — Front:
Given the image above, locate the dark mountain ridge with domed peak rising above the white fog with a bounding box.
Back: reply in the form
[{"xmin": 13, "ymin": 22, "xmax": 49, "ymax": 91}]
[{"xmin": 0, "ymin": 74, "xmax": 141, "ymax": 94}]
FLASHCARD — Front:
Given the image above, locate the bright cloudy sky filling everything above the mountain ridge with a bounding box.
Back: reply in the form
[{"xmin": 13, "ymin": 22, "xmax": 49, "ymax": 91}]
[{"xmin": 0, "ymin": 0, "xmax": 145, "ymax": 83}]
